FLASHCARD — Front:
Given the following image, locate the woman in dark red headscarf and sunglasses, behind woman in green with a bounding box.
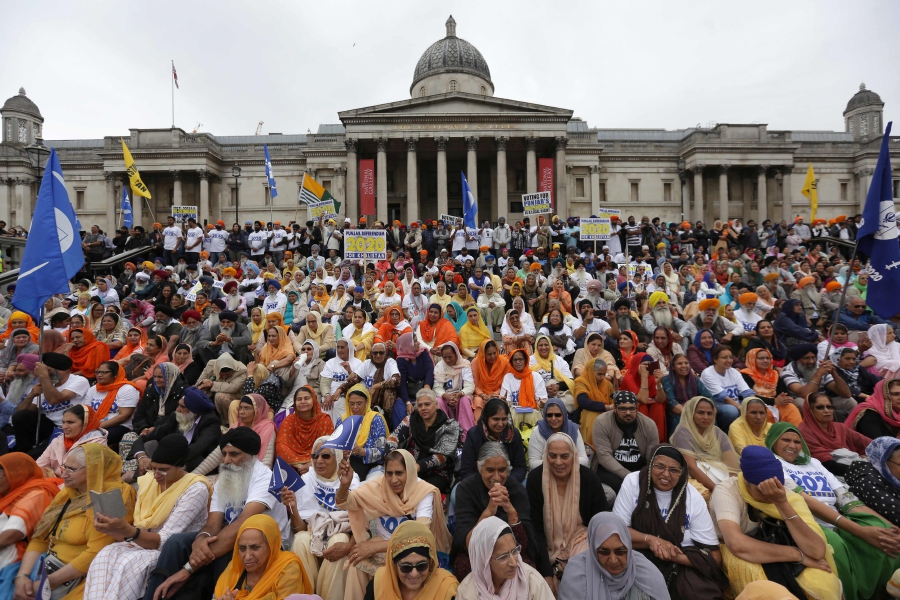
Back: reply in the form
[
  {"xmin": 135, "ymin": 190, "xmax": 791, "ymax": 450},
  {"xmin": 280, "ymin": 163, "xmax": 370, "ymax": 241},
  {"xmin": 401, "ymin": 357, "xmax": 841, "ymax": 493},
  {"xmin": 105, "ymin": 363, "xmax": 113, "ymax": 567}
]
[{"xmin": 800, "ymin": 393, "xmax": 872, "ymax": 477}]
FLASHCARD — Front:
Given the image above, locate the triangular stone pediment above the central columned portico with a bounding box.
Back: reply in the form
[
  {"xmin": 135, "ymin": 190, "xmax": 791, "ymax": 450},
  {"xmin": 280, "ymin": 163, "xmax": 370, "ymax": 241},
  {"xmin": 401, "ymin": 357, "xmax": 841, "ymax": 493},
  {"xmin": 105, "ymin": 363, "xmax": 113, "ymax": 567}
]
[{"xmin": 338, "ymin": 92, "xmax": 572, "ymax": 126}]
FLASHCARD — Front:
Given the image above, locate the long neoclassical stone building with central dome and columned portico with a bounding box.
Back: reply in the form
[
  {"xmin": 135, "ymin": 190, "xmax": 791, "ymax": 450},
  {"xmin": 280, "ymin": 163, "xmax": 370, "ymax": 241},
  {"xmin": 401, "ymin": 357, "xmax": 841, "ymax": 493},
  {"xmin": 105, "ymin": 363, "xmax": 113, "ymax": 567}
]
[{"xmin": 0, "ymin": 17, "xmax": 900, "ymax": 230}]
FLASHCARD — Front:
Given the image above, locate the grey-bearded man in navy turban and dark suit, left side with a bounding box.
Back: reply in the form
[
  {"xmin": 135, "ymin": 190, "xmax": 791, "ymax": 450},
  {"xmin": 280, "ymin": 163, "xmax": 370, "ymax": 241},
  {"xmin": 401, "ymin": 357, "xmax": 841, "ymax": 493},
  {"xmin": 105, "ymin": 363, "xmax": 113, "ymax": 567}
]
[{"xmin": 130, "ymin": 387, "xmax": 222, "ymax": 479}]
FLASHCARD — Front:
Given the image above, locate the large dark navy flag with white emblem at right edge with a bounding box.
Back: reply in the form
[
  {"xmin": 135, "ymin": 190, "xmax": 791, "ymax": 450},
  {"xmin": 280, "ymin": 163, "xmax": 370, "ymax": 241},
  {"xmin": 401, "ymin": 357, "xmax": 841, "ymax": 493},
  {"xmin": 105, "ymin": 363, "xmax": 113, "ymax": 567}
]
[{"xmin": 856, "ymin": 123, "xmax": 900, "ymax": 319}]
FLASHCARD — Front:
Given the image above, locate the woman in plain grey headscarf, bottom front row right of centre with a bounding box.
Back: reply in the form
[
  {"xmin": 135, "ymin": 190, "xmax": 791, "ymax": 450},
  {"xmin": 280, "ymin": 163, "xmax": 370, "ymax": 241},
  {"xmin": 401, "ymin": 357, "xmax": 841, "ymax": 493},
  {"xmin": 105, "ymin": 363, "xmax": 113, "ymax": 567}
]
[{"xmin": 559, "ymin": 512, "xmax": 671, "ymax": 600}]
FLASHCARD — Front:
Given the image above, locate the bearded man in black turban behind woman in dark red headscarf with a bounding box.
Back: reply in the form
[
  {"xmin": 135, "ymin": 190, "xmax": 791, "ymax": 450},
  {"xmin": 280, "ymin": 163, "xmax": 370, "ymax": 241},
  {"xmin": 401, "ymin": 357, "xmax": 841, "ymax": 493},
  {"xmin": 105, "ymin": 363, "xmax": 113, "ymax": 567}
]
[{"xmin": 781, "ymin": 344, "xmax": 856, "ymax": 420}]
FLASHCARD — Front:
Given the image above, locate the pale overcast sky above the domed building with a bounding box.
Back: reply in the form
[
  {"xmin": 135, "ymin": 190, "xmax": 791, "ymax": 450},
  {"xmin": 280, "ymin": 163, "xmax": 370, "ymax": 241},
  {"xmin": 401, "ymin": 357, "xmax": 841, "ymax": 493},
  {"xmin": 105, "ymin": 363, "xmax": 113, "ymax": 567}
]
[{"xmin": 0, "ymin": 0, "xmax": 900, "ymax": 139}]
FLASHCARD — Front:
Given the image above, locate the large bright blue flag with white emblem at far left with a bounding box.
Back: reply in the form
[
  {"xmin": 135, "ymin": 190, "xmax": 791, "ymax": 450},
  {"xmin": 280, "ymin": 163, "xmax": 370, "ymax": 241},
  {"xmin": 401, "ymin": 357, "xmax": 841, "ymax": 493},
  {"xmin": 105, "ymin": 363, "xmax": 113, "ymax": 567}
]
[{"xmin": 12, "ymin": 148, "xmax": 84, "ymax": 320}]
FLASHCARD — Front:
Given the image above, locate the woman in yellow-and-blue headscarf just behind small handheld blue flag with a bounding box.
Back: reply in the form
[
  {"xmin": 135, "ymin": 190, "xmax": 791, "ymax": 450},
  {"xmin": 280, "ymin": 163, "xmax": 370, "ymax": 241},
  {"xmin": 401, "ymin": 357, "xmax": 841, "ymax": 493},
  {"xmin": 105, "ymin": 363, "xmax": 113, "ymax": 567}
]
[{"xmin": 335, "ymin": 383, "xmax": 388, "ymax": 481}]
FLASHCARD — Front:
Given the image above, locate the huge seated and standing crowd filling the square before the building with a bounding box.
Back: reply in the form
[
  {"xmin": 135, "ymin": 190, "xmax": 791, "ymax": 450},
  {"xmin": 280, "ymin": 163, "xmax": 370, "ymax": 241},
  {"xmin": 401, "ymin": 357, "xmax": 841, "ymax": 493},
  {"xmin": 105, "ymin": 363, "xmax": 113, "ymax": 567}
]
[{"xmin": 0, "ymin": 215, "xmax": 900, "ymax": 600}]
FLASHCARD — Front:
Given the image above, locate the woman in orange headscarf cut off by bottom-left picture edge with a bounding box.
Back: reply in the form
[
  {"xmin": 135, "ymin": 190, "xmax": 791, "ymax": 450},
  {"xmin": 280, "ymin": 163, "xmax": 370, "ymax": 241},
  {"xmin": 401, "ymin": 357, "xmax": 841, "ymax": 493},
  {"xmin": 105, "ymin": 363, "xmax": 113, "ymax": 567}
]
[{"xmin": 0, "ymin": 452, "xmax": 62, "ymax": 569}]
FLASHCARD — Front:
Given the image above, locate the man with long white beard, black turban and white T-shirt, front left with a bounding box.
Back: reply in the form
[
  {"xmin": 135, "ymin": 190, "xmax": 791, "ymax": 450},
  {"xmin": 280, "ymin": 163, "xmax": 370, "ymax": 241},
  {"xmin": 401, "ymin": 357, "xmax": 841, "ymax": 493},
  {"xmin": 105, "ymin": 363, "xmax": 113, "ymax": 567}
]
[{"xmin": 145, "ymin": 427, "xmax": 291, "ymax": 600}]
